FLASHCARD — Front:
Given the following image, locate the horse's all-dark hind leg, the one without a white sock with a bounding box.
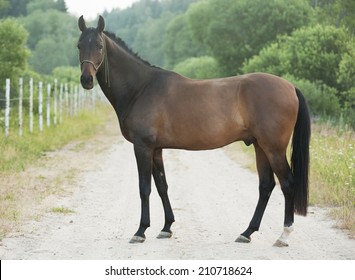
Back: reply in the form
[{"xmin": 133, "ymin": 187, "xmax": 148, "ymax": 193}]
[{"xmin": 236, "ymin": 143, "xmax": 275, "ymax": 243}]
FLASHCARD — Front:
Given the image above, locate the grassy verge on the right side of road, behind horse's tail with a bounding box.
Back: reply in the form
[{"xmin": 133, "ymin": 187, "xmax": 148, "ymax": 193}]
[{"xmin": 227, "ymin": 124, "xmax": 355, "ymax": 238}]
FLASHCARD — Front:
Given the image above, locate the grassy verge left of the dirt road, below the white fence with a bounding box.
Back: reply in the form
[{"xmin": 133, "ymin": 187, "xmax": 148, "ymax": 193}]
[{"xmin": 0, "ymin": 106, "xmax": 112, "ymax": 240}]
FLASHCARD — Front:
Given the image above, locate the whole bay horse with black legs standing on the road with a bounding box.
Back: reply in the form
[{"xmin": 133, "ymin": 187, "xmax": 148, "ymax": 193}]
[{"xmin": 78, "ymin": 16, "xmax": 310, "ymax": 246}]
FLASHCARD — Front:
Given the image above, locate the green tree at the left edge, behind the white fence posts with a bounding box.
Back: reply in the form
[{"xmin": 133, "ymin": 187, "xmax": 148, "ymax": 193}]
[{"xmin": 0, "ymin": 19, "xmax": 30, "ymax": 81}]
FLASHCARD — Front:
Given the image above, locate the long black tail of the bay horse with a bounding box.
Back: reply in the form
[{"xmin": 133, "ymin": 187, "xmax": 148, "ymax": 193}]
[{"xmin": 291, "ymin": 88, "xmax": 311, "ymax": 216}]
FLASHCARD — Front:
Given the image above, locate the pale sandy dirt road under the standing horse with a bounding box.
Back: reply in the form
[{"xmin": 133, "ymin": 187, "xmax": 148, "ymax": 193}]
[{"xmin": 0, "ymin": 119, "xmax": 355, "ymax": 260}]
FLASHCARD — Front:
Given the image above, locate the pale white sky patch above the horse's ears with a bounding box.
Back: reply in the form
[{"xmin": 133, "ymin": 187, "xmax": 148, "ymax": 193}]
[{"xmin": 65, "ymin": 0, "xmax": 138, "ymax": 19}]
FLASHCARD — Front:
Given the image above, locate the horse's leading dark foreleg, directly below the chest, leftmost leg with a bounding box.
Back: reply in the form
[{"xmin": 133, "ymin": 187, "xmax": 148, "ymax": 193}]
[{"xmin": 130, "ymin": 145, "xmax": 153, "ymax": 243}]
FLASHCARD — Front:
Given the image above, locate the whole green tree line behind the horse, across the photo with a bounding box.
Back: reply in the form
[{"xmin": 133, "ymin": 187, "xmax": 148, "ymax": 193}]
[{"xmin": 0, "ymin": 0, "xmax": 355, "ymax": 127}]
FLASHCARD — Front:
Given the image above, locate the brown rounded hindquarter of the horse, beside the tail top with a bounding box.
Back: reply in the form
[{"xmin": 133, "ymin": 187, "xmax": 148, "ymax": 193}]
[{"xmin": 240, "ymin": 73, "xmax": 298, "ymax": 149}]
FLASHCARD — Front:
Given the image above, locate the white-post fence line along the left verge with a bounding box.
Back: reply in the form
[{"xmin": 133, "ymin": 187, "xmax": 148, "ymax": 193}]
[{"xmin": 0, "ymin": 78, "xmax": 103, "ymax": 138}]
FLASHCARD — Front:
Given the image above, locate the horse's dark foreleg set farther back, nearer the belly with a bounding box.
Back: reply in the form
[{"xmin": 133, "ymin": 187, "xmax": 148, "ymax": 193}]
[{"xmin": 152, "ymin": 149, "xmax": 175, "ymax": 238}]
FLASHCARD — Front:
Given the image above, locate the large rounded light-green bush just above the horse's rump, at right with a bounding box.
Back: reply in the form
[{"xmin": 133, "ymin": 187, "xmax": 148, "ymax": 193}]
[{"xmin": 243, "ymin": 25, "xmax": 353, "ymax": 91}]
